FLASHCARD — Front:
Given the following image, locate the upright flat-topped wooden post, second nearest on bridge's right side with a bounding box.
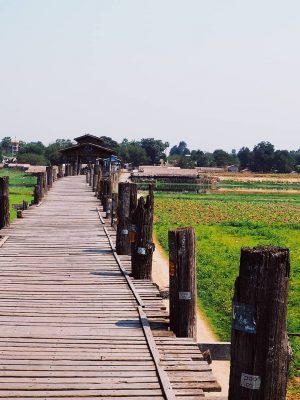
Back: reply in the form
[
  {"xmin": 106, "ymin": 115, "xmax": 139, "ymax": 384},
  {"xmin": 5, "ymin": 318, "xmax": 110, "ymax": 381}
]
[{"xmin": 169, "ymin": 227, "xmax": 197, "ymax": 338}]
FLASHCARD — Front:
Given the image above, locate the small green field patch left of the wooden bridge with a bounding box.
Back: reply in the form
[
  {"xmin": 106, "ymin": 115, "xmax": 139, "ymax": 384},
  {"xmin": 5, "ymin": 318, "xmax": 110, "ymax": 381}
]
[{"xmin": 0, "ymin": 169, "xmax": 36, "ymax": 221}]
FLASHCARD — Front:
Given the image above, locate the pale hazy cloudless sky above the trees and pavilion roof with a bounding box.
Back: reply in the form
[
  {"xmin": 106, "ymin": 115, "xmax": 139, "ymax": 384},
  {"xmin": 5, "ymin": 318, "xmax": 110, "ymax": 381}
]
[{"xmin": 0, "ymin": 0, "xmax": 300, "ymax": 151}]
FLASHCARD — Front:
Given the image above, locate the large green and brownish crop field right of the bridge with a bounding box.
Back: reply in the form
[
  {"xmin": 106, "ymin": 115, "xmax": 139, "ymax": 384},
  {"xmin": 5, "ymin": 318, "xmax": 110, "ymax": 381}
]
[{"xmin": 154, "ymin": 192, "xmax": 300, "ymax": 399}]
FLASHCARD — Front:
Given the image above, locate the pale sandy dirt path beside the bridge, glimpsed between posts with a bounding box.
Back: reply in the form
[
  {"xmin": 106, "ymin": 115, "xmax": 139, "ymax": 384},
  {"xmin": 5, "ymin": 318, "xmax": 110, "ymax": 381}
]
[{"xmin": 152, "ymin": 240, "xmax": 230, "ymax": 397}]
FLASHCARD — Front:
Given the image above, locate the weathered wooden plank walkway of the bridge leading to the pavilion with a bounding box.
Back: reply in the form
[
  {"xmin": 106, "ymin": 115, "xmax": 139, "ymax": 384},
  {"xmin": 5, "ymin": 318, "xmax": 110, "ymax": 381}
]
[{"xmin": 0, "ymin": 176, "xmax": 220, "ymax": 400}]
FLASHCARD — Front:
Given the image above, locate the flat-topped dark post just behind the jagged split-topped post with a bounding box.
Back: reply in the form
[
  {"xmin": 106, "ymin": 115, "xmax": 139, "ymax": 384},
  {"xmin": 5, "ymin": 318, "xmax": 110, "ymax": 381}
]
[{"xmin": 116, "ymin": 182, "xmax": 137, "ymax": 255}]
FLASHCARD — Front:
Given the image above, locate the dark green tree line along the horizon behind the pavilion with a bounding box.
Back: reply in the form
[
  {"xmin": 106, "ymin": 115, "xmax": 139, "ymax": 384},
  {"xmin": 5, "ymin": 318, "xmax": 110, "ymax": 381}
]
[{"xmin": 0, "ymin": 136, "xmax": 300, "ymax": 173}]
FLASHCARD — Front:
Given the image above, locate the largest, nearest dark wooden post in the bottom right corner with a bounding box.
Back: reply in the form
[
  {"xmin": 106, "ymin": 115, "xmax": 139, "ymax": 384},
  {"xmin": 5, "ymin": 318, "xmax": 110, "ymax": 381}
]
[{"xmin": 229, "ymin": 246, "xmax": 290, "ymax": 400}]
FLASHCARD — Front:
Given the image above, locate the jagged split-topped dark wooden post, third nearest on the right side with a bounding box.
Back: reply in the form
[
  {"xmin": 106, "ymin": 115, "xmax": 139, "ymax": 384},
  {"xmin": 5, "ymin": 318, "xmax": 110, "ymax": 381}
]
[{"xmin": 131, "ymin": 185, "xmax": 155, "ymax": 279}]
